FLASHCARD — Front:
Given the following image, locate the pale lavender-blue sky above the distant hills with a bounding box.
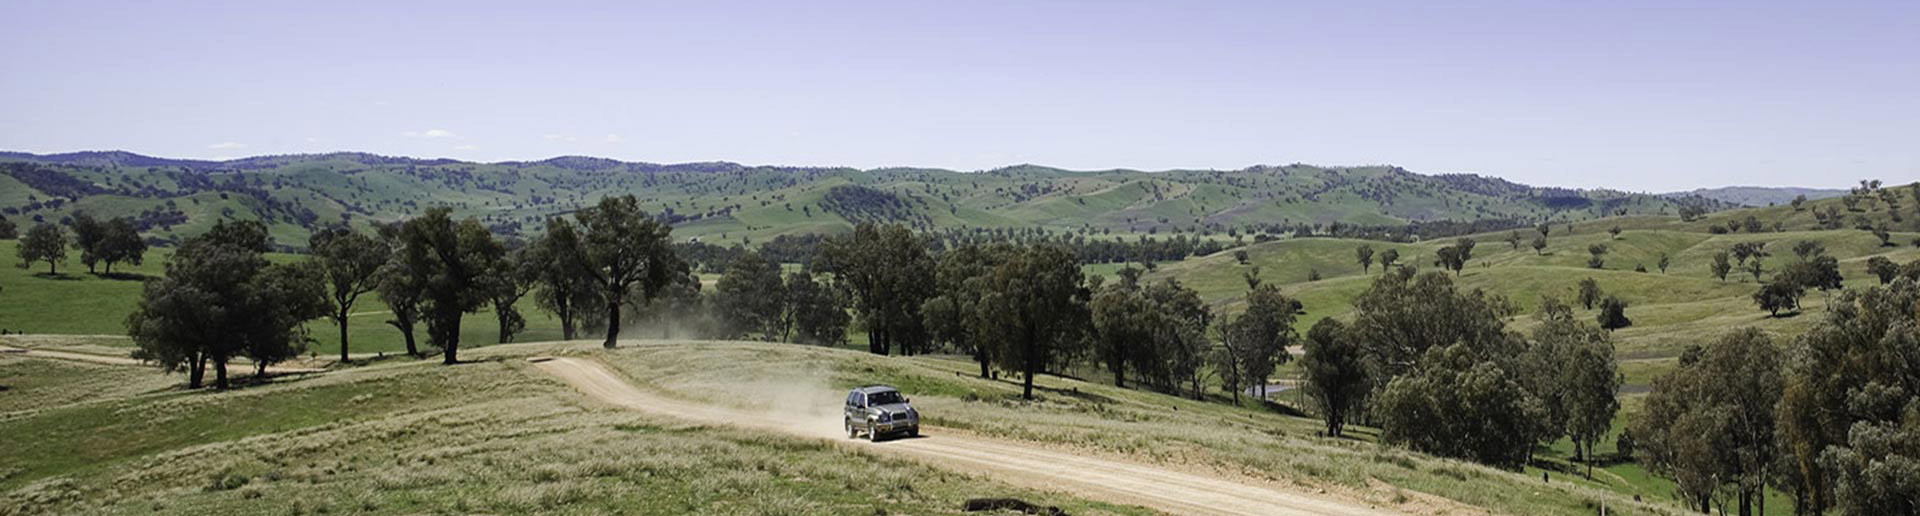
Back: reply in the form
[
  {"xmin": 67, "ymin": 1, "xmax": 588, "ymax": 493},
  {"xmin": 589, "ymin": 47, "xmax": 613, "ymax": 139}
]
[{"xmin": 0, "ymin": 0, "xmax": 1920, "ymax": 192}]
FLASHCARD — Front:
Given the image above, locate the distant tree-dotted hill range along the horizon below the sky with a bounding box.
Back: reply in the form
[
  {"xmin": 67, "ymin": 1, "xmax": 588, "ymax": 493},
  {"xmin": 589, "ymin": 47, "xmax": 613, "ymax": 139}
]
[{"xmin": 0, "ymin": 152, "xmax": 1758, "ymax": 246}]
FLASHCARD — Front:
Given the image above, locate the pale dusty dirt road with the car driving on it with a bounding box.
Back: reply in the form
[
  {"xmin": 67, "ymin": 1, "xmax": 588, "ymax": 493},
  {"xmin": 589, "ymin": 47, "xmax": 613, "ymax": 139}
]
[{"xmin": 534, "ymin": 359, "xmax": 1394, "ymax": 516}]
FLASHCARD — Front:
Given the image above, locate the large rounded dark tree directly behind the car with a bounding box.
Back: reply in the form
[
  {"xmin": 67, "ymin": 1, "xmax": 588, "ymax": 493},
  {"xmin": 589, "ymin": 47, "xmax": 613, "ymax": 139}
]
[{"xmin": 814, "ymin": 223, "xmax": 935, "ymax": 355}]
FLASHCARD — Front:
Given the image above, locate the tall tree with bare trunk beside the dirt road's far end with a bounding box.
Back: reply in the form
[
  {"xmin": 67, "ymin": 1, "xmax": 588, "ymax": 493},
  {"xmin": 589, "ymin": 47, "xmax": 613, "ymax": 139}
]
[{"xmin": 574, "ymin": 196, "xmax": 689, "ymax": 349}]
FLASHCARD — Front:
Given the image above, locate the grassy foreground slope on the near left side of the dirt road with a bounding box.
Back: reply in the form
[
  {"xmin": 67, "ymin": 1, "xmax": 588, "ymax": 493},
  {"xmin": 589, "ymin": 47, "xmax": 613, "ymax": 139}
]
[{"xmin": 0, "ymin": 339, "xmax": 1142, "ymax": 514}]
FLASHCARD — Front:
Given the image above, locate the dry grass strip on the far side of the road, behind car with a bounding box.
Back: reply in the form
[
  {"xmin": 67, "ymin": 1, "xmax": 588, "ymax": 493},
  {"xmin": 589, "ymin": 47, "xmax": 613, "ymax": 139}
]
[{"xmin": 599, "ymin": 343, "xmax": 1682, "ymax": 516}]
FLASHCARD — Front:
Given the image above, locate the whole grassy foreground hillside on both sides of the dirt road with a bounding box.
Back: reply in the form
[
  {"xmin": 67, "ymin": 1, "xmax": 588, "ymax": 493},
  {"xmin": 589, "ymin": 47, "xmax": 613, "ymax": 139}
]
[{"xmin": 0, "ymin": 341, "xmax": 1712, "ymax": 516}]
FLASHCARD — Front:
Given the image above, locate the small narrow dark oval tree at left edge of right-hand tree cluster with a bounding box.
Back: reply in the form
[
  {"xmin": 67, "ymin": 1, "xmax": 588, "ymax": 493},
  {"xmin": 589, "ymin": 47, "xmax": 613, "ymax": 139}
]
[{"xmin": 1300, "ymin": 317, "xmax": 1369, "ymax": 437}]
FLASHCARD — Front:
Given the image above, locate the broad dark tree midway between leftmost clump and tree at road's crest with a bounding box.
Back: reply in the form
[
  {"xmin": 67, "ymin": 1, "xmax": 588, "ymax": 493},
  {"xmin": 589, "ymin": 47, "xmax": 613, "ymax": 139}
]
[{"xmin": 394, "ymin": 207, "xmax": 507, "ymax": 364}]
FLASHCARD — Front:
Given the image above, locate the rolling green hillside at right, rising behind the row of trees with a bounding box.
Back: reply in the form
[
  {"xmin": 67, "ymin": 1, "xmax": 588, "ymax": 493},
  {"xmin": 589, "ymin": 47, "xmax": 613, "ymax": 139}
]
[{"xmin": 1136, "ymin": 186, "xmax": 1920, "ymax": 386}]
